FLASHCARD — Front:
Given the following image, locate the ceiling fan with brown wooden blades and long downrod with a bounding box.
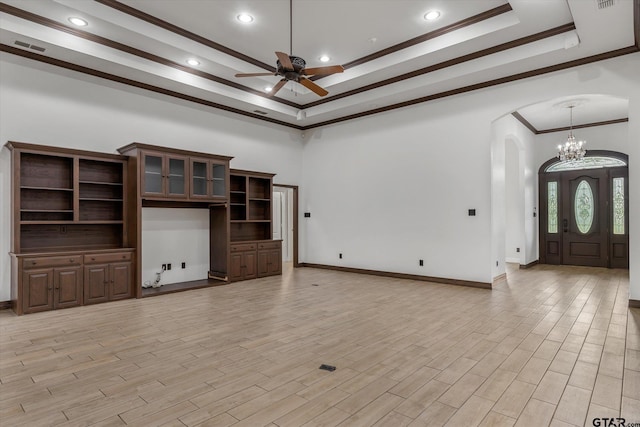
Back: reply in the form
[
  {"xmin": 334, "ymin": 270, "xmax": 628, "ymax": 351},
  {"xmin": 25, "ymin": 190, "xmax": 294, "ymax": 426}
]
[{"xmin": 236, "ymin": 0, "xmax": 344, "ymax": 96}]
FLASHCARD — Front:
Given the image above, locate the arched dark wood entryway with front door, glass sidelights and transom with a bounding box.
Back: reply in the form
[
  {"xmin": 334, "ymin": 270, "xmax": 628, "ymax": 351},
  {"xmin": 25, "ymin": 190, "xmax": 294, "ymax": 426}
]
[{"xmin": 538, "ymin": 150, "xmax": 629, "ymax": 268}]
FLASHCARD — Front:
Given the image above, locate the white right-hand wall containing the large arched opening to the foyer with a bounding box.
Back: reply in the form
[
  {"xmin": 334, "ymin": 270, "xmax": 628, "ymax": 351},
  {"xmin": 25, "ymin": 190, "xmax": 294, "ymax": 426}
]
[{"xmin": 301, "ymin": 54, "xmax": 640, "ymax": 291}]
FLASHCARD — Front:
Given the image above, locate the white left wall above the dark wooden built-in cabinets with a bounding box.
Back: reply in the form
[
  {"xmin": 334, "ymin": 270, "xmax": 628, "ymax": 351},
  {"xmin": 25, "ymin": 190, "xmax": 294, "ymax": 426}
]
[{"xmin": 0, "ymin": 54, "xmax": 302, "ymax": 301}]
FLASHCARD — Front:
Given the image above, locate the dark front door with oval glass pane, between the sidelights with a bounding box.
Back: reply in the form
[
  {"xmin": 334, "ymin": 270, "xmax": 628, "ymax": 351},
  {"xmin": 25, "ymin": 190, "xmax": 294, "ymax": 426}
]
[{"xmin": 559, "ymin": 169, "xmax": 609, "ymax": 267}]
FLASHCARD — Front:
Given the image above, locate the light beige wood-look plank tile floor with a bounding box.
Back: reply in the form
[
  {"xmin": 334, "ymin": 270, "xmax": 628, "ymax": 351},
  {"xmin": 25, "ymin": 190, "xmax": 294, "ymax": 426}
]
[{"xmin": 0, "ymin": 266, "xmax": 640, "ymax": 427}]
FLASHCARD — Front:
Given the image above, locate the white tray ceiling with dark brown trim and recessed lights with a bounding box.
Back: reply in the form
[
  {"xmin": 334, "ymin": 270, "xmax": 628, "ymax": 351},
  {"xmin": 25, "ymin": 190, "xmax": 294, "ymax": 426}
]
[{"xmin": 0, "ymin": 0, "xmax": 640, "ymax": 130}]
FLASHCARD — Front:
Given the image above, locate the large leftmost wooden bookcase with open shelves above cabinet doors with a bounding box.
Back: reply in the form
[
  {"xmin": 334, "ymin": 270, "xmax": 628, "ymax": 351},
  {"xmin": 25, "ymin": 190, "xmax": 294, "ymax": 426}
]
[{"xmin": 7, "ymin": 142, "xmax": 135, "ymax": 314}]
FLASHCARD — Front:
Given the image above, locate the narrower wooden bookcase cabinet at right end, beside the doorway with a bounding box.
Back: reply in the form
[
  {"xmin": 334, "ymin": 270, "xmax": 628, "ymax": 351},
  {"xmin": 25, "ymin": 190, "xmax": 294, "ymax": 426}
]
[{"xmin": 229, "ymin": 169, "xmax": 282, "ymax": 281}]
